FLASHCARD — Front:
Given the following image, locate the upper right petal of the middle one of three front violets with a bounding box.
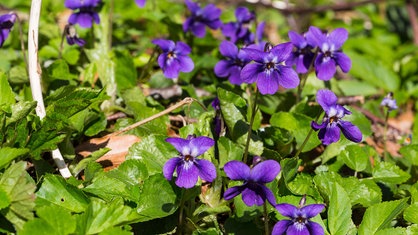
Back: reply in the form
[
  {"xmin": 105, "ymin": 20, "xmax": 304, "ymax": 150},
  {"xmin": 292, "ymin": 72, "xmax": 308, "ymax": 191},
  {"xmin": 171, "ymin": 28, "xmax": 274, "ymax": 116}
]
[{"xmin": 249, "ymin": 160, "xmax": 280, "ymax": 184}]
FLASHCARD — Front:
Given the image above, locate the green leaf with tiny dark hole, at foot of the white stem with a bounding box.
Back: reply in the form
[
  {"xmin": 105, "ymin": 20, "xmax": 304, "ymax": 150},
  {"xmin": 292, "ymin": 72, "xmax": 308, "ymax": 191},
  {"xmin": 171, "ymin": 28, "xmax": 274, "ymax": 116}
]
[{"xmin": 36, "ymin": 175, "xmax": 89, "ymax": 213}]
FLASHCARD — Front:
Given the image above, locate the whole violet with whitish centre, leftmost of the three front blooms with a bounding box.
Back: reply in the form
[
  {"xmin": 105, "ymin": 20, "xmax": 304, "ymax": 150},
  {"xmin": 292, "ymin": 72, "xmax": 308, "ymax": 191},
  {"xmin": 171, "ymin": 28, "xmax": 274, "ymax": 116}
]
[{"xmin": 163, "ymin": 135, "xmax": 216, "ymax": 188}]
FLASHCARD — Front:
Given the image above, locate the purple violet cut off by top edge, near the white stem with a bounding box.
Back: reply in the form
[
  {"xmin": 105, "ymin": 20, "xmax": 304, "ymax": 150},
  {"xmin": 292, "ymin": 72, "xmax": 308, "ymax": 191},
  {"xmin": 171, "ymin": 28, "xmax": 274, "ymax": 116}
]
[{"xmin": 64, "ymin": 0, "xmax": 101, "ymax": 28}]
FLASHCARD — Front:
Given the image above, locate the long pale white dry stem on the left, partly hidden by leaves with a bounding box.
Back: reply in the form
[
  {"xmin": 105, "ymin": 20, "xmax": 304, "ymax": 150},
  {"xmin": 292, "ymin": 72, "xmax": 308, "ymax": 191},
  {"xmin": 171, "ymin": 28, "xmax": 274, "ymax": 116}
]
[{"xmin": 28, "ymin": 0, "xmax": 71, "ymax": 178}]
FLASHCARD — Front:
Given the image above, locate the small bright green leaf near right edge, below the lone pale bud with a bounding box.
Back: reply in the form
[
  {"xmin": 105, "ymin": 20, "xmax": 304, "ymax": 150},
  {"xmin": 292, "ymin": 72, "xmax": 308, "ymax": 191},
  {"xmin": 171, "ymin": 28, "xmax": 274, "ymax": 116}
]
[{"xmin": 373, "ymin": 162, "xmax": 411, "ymax": 184}]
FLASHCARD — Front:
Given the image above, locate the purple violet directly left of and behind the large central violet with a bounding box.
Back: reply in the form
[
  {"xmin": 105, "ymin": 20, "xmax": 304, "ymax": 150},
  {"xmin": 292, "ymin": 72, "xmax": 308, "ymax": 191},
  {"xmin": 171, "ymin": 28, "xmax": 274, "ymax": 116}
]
[{"xmin": 214, "ymin": 41, "xmax": 250, "ymax": 85}]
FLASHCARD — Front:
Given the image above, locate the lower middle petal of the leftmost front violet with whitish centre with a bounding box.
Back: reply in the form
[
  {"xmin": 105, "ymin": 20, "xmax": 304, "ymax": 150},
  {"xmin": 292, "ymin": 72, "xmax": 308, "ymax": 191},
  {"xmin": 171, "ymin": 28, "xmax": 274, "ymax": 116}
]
[{"xmin": 176, "ymin": 161, "xmax": 199, "ymax": 188}]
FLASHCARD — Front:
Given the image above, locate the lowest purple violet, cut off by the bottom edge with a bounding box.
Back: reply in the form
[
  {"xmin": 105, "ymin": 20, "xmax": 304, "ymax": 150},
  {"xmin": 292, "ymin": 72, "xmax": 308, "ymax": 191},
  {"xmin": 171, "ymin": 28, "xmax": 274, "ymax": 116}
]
[{"xmin": 271, "ymin": 196, "xmax": 325, "ymax": 235}]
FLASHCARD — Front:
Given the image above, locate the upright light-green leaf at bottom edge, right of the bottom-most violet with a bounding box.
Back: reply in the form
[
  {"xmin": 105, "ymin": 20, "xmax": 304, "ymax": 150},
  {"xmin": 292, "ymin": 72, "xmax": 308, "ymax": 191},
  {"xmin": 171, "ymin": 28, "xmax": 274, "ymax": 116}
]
[{"xmin": 328, "ymin": 183, "xmax": 355, "ymax": 235}]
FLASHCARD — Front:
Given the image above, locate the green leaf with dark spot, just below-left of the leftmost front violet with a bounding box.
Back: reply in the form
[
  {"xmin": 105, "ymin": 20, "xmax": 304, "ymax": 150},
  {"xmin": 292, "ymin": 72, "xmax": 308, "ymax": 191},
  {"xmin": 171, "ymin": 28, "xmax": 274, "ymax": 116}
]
[{"xmin": 137, "ymin": 173, "xmax": 180, "ymax": 222}]
